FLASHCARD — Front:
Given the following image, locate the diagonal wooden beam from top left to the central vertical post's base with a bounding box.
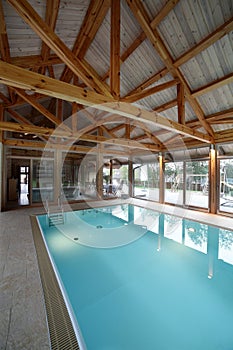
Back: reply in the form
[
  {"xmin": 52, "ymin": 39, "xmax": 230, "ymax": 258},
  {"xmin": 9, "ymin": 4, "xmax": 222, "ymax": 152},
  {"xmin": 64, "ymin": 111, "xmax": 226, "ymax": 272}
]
[{"xmin": 8, "ymin": 0, "xmax": 110, "ymax": 96}]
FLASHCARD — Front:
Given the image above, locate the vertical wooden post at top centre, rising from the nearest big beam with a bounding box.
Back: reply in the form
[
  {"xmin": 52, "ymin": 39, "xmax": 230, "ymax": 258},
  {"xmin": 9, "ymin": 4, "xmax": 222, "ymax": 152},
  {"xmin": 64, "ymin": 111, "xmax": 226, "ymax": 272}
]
[{"xmin": 110, "ymin": 0, "xmax": 121, "ymax": 99}]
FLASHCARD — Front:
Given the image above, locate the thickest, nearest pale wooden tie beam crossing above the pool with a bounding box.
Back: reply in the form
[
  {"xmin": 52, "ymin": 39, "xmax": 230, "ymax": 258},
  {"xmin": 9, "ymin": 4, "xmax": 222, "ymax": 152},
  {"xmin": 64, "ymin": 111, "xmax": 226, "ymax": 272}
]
[{"xmin": 0, "ymin": 61, "xmax": 213, "ymax": 143}]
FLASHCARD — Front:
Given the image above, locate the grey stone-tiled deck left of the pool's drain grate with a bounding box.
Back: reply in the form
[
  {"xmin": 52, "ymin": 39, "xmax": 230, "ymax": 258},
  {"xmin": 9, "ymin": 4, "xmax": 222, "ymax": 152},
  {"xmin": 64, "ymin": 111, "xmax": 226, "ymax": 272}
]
[{"xmin": 0, "ymin": 209, "xmax": 50, "ymax": 350}]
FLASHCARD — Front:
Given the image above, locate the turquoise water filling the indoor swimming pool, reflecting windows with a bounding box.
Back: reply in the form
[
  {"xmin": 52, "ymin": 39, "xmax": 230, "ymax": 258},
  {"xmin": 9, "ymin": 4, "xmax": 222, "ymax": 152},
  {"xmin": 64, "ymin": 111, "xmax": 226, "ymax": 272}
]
[{"xmin": 38, "ymin": 205, "xmax": 233, "ymax": 350}]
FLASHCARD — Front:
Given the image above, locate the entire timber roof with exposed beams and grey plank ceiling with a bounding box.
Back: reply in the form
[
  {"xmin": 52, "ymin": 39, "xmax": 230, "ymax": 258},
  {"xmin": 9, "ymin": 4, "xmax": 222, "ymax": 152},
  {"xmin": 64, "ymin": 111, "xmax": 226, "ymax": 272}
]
[{"xmin": 0, "ymin": 0, "xmax": 233, "ymax": 155}]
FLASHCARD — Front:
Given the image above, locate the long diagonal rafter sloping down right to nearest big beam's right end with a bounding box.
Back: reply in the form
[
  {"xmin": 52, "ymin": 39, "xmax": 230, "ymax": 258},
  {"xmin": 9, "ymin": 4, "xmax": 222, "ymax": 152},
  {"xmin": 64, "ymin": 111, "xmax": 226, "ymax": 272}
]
[{"xmin": 127, "ymin": 0, "xmax": 214, "ymax": 138}]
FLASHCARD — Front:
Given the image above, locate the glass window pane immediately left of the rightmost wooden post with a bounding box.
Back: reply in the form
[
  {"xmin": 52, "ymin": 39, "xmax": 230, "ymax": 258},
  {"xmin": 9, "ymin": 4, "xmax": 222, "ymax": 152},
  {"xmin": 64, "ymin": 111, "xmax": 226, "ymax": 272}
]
[{"xmin": 185, "ymin": 160, "xmax": 209, "ymax": 208}]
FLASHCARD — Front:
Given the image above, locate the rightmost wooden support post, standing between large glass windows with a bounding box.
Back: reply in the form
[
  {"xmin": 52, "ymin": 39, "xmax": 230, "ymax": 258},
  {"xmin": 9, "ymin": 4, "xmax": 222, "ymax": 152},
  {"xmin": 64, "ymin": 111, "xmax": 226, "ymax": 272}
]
[{"xmin": 209, "ymin": 145, "xmax": 218, "ymax": 214}]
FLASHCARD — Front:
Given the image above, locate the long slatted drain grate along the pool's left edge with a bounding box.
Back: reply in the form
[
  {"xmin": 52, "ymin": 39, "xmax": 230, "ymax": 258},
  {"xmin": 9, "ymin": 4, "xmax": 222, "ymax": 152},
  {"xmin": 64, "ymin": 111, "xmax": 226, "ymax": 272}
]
[{"xmin": 30, "ymin": 216, "xmax": 80, "ymax": 350}]
